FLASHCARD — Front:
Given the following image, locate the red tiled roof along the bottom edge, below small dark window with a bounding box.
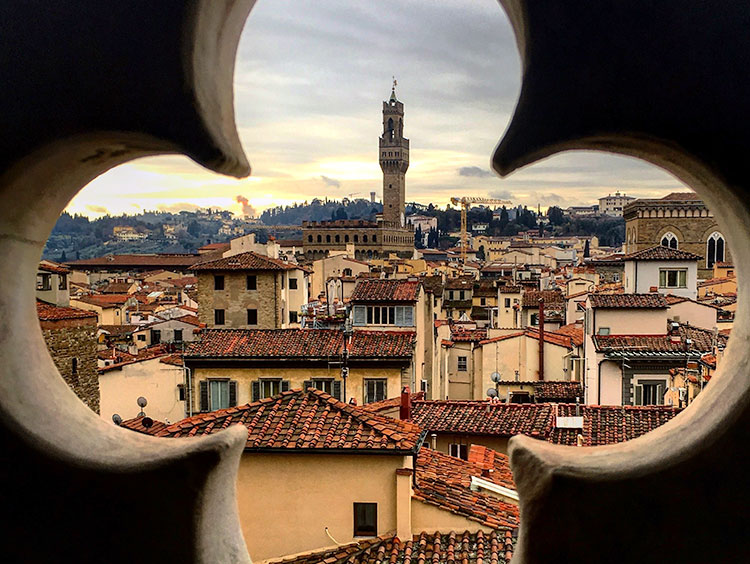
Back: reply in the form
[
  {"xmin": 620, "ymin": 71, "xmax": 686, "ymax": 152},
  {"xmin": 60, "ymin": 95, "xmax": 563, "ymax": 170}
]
[{"xmin": 269, "ymin": 531, "xmax": 513, "ymax": 564}]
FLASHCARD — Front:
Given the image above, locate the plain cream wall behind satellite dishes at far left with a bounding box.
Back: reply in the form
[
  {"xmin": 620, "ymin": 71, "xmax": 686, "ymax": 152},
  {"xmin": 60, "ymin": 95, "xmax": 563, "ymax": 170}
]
[{"xmin": 99, "ymin": 358, "xmax": 185, "ymax": 423}]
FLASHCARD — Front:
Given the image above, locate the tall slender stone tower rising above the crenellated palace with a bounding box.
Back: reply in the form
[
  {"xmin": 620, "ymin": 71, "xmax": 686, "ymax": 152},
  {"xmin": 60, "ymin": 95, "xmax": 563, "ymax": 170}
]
[{"xmin": 380, "ymin": 80, "xmax": 409, "ymax": 227}]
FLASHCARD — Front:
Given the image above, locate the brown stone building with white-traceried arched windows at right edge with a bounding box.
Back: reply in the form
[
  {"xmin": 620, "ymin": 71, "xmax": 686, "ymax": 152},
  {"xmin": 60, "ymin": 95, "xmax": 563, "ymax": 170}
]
[{"xmin": 624, "ymin": 192, "xmax": 732, "ymax": 279}]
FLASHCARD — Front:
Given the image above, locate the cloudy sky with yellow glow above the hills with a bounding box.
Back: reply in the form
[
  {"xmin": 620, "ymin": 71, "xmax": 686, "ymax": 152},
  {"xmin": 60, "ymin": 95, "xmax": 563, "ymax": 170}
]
[{"xmin": 68, "ymin": 0, "xmax": 685, "ymax": 217}]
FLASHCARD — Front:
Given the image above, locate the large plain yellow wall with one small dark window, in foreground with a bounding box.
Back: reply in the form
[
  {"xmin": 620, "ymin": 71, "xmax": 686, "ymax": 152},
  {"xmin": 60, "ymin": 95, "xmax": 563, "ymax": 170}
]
[{"xmin": 237, "ymin": 453, "xmax": 412, "ymax": 561}]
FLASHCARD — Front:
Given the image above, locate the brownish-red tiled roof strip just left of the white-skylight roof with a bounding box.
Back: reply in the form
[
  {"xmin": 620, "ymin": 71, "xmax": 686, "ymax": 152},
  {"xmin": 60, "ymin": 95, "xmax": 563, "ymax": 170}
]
[{"xmin": 412, "ymin": 400, "xmax": 552, "ymax": 437}]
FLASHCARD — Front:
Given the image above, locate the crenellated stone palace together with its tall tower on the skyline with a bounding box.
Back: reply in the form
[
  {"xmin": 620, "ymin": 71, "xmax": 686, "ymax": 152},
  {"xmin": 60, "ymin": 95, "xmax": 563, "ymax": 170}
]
[{"xmin": 302, "ymin": 84, "xmax": 414, "ymax": 260}]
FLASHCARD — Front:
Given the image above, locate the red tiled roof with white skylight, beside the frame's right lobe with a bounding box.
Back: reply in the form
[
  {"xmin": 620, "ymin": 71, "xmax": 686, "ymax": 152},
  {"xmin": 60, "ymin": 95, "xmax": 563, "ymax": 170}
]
[{"xmin": 547, "ymin": 404, "xmax": 681, "ymax": 446}]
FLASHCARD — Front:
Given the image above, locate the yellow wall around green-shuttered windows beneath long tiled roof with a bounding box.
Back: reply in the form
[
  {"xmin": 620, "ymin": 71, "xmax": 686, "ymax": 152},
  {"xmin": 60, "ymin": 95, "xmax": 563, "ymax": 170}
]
[{"xmin": 193, "ymin": 359, "xmax": 402, "ymax": 410}]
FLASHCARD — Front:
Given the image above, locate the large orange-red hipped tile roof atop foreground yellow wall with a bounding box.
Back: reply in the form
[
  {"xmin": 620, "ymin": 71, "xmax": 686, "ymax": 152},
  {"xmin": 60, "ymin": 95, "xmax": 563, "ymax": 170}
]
[{"xmin": 155, "ymin": 388, "xmax": 423, "ymax": 454}]
